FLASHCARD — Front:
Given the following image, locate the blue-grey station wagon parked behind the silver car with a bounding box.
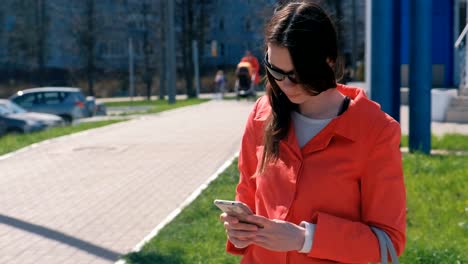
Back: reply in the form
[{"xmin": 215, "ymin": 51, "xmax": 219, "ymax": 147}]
[{"xmin": 10, "ymin": 87, "xmax": 94, "ymax": 123}]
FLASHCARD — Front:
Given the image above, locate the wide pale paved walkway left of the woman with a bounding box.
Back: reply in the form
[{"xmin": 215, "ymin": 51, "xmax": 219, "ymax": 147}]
[{"xmin": 0, "ymin": 101, "xmax": 253, "ymax": 264}]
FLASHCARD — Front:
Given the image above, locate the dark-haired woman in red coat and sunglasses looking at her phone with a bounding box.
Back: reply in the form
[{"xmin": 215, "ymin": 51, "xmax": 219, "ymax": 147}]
[{"xmin": 220, "ymin": 2, "xmax": 406, "ymax": 263}]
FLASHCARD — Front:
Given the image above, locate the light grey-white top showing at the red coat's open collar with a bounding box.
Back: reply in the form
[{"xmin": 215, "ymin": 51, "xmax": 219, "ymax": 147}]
[{"xmin": 291, "ymin": 111, "xmax": 333, "ymax": 148}]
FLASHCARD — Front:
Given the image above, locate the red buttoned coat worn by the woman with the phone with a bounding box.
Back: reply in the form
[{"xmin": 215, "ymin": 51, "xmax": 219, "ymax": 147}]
[{"xmin": 227, "ymin": 85, "xmax": 406, "ymax": 264}]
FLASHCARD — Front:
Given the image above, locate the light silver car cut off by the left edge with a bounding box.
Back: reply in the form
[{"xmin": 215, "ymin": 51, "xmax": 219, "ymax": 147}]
[{"xmin": 0, "ymin": 99, "xmax": 65, "ymax": 127}]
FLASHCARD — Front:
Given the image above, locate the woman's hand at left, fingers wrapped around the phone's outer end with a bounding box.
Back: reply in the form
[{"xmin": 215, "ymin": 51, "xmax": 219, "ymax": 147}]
[{"xmin": 219, "ymin": 213, "xmax": 259, "ymax": 248}]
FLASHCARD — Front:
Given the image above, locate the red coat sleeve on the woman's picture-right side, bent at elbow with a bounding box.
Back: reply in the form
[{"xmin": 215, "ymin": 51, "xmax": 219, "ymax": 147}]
[{"xmin": 309, "ymin": 120, "xmax": 406, "ymax": 263}]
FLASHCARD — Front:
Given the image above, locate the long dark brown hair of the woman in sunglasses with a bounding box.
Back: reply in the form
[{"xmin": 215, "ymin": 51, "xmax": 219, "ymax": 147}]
[{"xmin": 259, "ymin": 1, "xmax": 341, "ymax": 172}]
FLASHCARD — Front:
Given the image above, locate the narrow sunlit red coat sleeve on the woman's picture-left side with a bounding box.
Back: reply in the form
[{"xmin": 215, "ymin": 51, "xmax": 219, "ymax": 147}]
[{"xmin": 226, "ymin": 99, "xmax": 260, "ymax": 255}]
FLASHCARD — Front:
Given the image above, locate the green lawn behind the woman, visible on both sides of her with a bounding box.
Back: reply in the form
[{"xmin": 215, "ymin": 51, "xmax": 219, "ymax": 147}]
[{"xmin": 125, "ymin": 136, "xmax": 468, "ymax": 264}]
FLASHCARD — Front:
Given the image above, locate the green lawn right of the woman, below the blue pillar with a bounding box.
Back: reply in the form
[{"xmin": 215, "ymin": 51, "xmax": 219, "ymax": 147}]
[{"xmin": 401, "ymin": 154, "xmax": 468, "ymax": 264}]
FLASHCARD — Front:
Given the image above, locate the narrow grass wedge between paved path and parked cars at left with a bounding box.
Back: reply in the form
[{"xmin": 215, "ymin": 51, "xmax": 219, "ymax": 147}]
[{"xmin": 0, "ymin": 120, "xmax": 125, "ymax": 155}]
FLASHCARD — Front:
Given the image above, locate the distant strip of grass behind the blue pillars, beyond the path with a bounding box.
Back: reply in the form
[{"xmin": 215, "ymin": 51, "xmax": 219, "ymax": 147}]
[{"xmin": 401, "ymin": 134, "xmax": 468, "ymax": 151}]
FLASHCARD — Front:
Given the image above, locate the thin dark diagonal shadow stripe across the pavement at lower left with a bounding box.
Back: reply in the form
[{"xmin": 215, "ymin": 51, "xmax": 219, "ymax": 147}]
[{"xmin": 0, "ymin": 214, "xmax": 122, "ymax": 261}]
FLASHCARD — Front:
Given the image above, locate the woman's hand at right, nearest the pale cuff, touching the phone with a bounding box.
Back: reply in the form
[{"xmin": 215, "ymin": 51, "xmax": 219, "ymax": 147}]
[{"xmin": 245, "ymin": 215, "xmax": 305, "ymax": 251}]
